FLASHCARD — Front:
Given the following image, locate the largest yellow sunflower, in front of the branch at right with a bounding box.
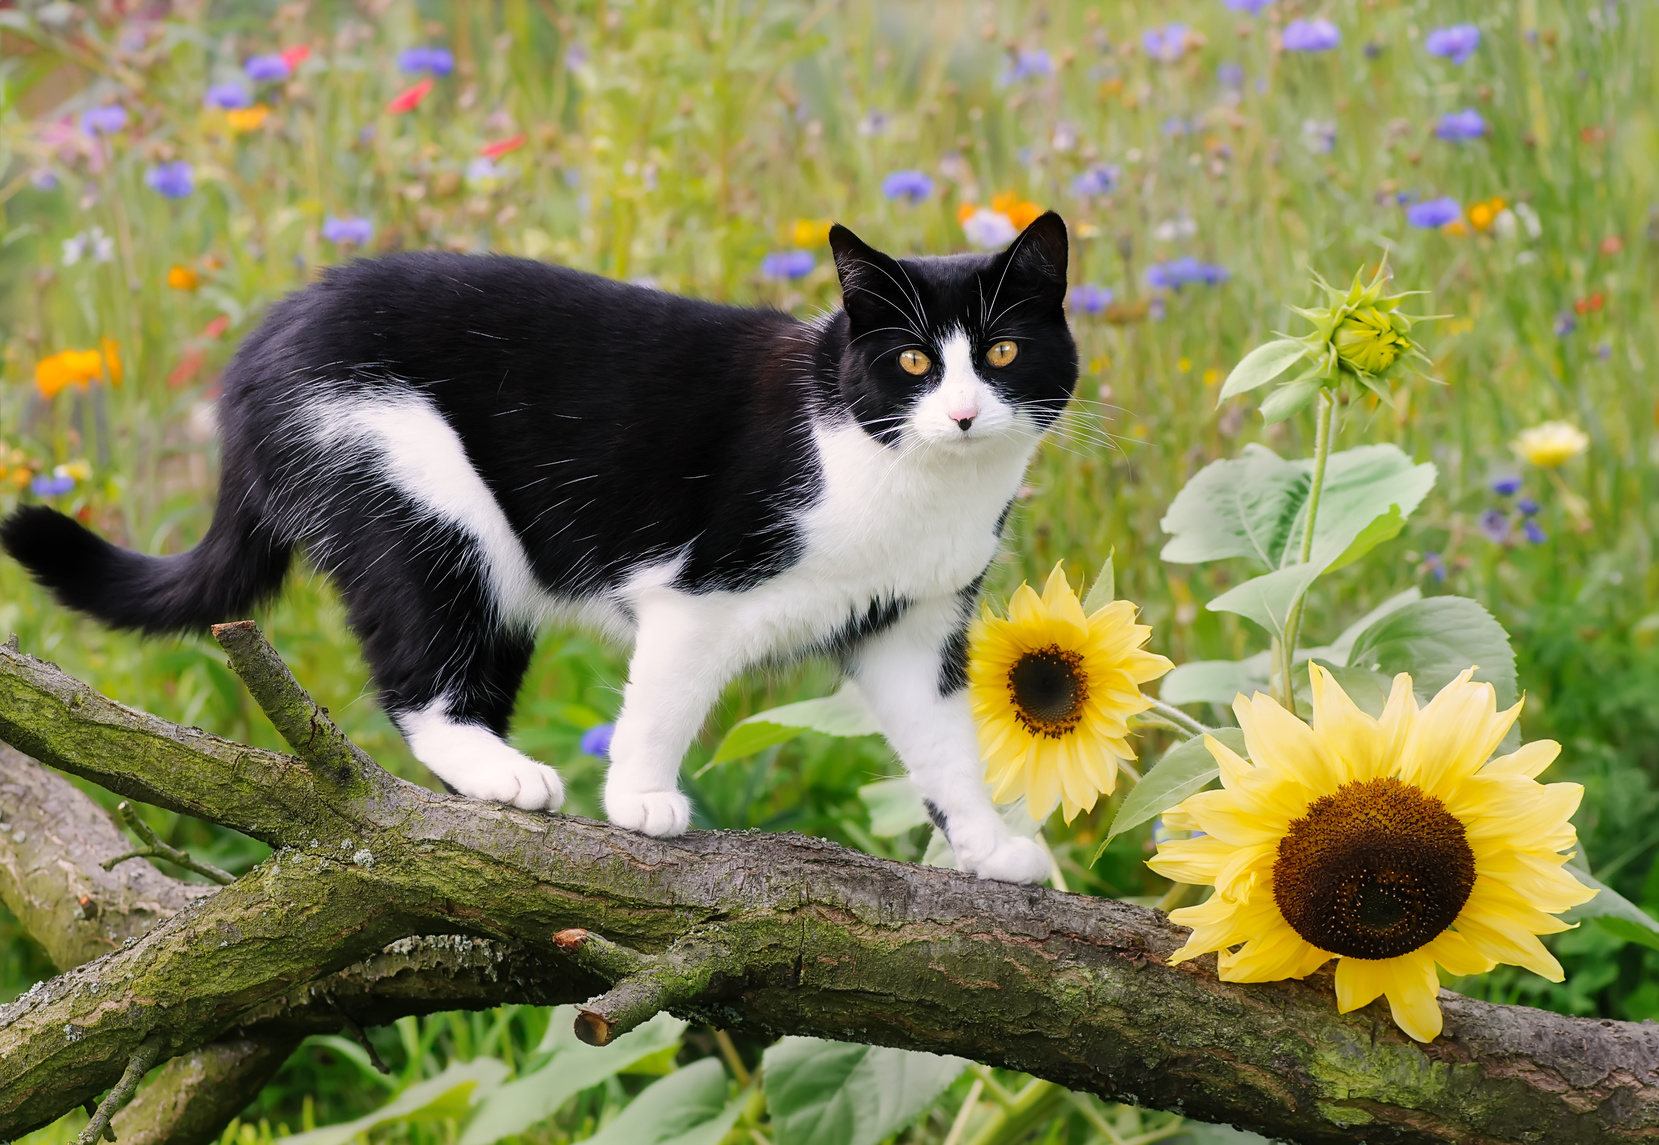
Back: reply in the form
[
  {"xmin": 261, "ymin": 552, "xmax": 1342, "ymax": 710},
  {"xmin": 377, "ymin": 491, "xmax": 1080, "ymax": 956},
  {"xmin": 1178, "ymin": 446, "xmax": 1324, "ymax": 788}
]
[{"xmin": 1150, "ymin": 664, "xmax": 1594, "ymax": 1042}]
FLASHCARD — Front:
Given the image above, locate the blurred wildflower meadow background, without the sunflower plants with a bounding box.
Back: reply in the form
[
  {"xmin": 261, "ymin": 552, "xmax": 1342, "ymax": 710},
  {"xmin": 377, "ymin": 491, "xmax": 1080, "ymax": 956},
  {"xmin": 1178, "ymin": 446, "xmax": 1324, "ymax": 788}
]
[{"xmin": 0, "ymin": 0, "xmax": 1659, "ymax": 1145}]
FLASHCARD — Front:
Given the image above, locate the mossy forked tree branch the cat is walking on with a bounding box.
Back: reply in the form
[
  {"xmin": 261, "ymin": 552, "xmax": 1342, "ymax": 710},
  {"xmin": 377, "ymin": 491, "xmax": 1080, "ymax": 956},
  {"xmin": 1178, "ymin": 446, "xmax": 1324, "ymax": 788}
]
[{"xmin": 0, "ymin": 633, "xmax": 1659, "ymax": 1143}]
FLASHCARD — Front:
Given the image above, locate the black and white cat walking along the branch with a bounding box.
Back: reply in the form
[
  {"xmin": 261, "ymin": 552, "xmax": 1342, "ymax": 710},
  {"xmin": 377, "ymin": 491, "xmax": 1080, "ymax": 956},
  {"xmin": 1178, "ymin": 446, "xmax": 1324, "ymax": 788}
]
[{"xmin": 0, "ymin": 212, "xmax": 1077, "ymax": 881}]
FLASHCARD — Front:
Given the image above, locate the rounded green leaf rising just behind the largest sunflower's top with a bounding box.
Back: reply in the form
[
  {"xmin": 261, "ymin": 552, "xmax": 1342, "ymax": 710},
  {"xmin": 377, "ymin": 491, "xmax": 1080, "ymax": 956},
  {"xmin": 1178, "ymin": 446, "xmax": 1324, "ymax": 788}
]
[{"xmin": 1347, "ymin": 596, "xmax": 1518, "ymax": 709}]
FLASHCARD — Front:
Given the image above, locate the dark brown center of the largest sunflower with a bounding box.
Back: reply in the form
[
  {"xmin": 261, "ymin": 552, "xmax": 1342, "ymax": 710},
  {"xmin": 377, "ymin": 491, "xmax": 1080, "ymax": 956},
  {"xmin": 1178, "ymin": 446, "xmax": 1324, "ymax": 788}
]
[{"xmin": 1272, "ymin": 778, "xmax": 1475, "ymax": 959}]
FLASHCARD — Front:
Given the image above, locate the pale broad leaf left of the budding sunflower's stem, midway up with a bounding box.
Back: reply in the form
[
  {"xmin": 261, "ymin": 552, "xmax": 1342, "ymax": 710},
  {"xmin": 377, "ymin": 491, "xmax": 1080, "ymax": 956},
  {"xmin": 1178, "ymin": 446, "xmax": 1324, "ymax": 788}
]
[{"xmin": 1158, "ymin": 443, "xmax": 1311, "ymax": 569}]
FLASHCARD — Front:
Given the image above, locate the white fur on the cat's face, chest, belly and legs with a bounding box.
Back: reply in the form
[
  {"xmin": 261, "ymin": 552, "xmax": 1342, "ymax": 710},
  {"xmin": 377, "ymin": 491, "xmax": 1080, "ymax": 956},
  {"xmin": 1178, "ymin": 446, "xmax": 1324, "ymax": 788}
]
[{"xmin": 307, "ymin": 351, "xmax": 1048, "ymax": 881}]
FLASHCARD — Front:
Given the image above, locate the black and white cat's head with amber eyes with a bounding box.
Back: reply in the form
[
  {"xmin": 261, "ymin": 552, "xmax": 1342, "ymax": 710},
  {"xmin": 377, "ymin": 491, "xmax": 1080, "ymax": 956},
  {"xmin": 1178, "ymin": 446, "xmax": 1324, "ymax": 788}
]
[{"xmin": 830, "ymin": 211, "xmax": 1077, "ymax": 448}]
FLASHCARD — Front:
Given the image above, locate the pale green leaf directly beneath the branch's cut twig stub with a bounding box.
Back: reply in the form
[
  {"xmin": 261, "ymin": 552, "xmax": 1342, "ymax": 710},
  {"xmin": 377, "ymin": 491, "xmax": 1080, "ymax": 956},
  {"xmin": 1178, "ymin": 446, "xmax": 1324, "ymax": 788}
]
[{"xmin": 461, "ymin": 1006, "xmax": 687, "ymax": 1145}]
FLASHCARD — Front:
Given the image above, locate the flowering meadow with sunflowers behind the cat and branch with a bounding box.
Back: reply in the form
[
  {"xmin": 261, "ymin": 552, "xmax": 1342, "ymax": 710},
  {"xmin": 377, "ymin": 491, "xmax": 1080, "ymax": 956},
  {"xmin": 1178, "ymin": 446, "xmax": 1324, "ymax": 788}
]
[{"xmin": 0, "ymin": 0, "xmax": 1659, "ymax": 1145}]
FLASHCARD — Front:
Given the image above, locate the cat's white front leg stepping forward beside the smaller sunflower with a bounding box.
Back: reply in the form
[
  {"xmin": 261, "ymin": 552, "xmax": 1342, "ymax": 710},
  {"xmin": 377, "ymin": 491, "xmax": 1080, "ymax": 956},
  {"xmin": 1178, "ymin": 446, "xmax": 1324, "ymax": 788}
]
[{"xmin": 851, "ymin": 597, "xmax": 1050, "ymax": 883}]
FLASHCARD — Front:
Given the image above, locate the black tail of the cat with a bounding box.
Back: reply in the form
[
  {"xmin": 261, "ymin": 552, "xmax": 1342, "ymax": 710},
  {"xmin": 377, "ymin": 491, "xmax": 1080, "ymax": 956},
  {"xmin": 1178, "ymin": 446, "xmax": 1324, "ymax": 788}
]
[{"xmin": 0, "ymin": 496, "xmax": 294, "ymax": 632}]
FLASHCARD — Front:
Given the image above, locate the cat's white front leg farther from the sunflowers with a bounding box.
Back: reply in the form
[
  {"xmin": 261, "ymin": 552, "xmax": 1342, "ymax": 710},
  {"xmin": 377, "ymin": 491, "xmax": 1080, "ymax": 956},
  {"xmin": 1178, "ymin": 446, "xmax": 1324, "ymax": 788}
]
[{"xmin": 604, "ymin": 592, "xmax": 742, "ymax": 838}]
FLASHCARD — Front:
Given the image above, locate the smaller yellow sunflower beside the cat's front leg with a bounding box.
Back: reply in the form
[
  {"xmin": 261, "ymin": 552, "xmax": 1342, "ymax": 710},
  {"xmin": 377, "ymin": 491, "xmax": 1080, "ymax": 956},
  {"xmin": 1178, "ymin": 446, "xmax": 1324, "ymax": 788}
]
[{"xmin": 967, "ymin": 564, "xmax": 1175, "ymax": 823}]
